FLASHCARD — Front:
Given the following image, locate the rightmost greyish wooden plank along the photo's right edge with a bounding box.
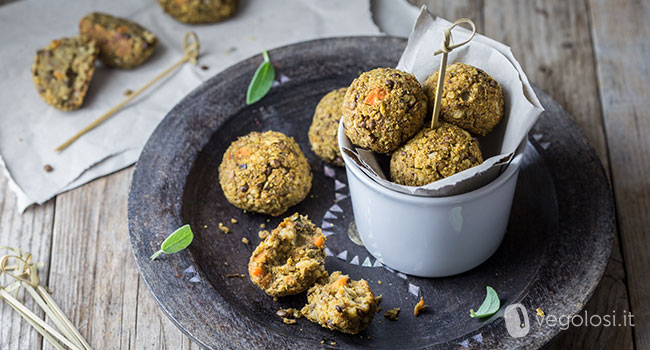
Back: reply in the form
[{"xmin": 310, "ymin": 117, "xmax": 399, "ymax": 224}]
[{"xmin": 589, "ymin": 0, "xmax": 650, "ymax": 349}]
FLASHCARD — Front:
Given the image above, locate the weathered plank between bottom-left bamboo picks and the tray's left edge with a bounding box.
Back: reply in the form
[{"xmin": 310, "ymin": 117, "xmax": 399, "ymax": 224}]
[{"xmin": 44, "ymin": 168, "xmax": 197, "ymax": 349}]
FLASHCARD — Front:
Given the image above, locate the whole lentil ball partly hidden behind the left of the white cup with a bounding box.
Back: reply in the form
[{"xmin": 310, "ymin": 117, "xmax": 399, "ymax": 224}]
[{"xmin": 308, "ymin": 88, "xmax": 348, "ymax": 166}]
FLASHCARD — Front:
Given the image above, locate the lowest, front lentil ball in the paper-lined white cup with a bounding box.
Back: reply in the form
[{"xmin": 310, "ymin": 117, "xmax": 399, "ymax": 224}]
[{"xmin": 390, "ymin": 122, "xmax": 483, "ymax": 186}]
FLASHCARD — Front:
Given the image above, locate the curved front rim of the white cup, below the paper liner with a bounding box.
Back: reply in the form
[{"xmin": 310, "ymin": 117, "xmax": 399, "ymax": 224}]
[{"xmin": 337, "ymin": 119, "xmax": 527, "ymax": 206}]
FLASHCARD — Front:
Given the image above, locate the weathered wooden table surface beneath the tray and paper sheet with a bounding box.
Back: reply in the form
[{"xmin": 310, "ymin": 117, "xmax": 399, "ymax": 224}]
[{"xmin": 0, "ymin": 0, "xmax": 650, "ymax": 350}]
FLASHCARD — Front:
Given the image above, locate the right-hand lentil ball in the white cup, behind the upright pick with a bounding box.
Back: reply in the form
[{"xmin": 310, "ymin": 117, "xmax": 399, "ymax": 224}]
[{"xmin": 424, "ymin": 63, "xmax": 504, "ymax": 136}]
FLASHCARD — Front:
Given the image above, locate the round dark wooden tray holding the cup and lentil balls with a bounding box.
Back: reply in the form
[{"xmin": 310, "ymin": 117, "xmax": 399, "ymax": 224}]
[{"xmin": 129, "ymin": 37, "xmax": 614, "ymax": 349}]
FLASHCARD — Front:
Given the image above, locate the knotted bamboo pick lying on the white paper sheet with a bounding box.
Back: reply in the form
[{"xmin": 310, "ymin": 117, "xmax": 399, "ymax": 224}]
[{"xmin": 54, "ymin": 32, "xmax": 200, "ymax": 152}]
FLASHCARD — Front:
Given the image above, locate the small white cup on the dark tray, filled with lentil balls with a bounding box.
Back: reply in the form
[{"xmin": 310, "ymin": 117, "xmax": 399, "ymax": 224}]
[{"xmin": 338, "ymin": 123, "xmax": 525, "ymax": 277}]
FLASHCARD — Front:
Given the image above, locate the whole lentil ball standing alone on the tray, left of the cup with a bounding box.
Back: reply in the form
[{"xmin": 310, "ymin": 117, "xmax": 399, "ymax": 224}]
[{"xmin": 219, "ymin": 131, "xmax": 312, "ymax": 216}]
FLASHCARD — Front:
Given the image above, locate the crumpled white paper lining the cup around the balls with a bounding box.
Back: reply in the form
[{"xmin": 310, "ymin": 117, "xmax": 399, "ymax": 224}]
[{"xmin": 339, "ymin": 6, "xmax": 544, "ymax": 197}]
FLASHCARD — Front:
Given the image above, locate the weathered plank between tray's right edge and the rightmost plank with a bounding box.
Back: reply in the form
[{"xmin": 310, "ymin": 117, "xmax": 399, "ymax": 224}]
[{"xmin": 484, "ymin": 0, "xmax": 633, "ymax": 349}]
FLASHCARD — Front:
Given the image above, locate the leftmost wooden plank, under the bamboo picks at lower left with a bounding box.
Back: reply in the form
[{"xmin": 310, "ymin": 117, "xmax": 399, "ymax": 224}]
[{"xmin": 0, "ymin": 173, "xmax": 54, "ymax": 349}]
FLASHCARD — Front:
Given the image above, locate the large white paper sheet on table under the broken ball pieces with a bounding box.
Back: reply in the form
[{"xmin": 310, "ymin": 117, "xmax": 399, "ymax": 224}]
[{"xmin": 0, "ymin": 0, "xmax": 380, "ymax": 211}]
